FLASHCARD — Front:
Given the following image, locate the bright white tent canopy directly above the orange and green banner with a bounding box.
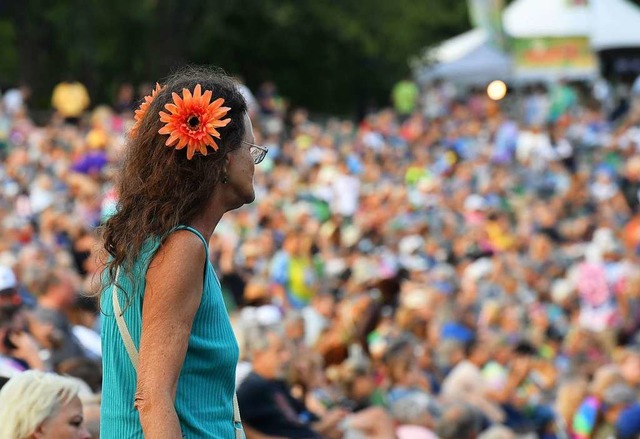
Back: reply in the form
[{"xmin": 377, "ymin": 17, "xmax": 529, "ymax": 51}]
[{"xmin": 502, "ymin": 0, "xmax": 592, "ymax": 38}]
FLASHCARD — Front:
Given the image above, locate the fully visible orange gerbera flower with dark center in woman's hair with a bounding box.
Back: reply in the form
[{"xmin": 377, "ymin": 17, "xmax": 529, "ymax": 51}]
[{"xmin": 158, "ymin": 84, "xmax": 231, "ymax": 160}]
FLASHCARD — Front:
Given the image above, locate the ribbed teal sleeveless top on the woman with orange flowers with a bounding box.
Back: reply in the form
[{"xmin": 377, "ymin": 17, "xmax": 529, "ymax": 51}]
[{"xmin": 100, "ymin": 226, "xmax": 239, "ymax": 439}]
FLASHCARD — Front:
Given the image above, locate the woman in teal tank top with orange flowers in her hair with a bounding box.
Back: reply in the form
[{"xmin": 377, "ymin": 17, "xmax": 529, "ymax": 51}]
[{"xmin": 101, "ymin": 69, "xmax": 266, "ymax": 439}]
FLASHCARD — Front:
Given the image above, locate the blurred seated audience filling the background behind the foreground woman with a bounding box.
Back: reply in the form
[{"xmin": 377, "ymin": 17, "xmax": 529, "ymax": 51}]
[{"xmin": 0, "ymin": 74, "xmax": 640, "ymax": 439}]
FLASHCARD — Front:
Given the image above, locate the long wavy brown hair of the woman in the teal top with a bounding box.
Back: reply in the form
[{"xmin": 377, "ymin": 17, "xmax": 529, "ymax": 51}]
[{"xmin": 101, "ymin": 67, "xmax": 247, "ymax": 305}]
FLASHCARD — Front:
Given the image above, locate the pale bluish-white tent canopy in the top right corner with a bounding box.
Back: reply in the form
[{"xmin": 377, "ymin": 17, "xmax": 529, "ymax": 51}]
[{"xmin": 590, "ymin": 0, "xmax": 640, "ymax": 50}]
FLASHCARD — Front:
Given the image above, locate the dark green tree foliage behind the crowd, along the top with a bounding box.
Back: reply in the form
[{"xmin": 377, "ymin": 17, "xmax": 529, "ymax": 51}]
[{"xmin": 0, "ymin": 0, "xmax": 469, "ymax": 113}]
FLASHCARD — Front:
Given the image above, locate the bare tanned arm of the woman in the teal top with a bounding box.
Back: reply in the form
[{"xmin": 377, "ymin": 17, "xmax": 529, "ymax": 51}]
[{"xmin": 135, "ymin": 231, "xmax": 206, "ymax": 439}]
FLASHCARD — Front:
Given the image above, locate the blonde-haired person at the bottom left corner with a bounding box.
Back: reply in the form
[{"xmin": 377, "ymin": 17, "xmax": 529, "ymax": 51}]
[{"xmin": 0, "ymin": 370, "xmax": 91, "ymax": 439}]
